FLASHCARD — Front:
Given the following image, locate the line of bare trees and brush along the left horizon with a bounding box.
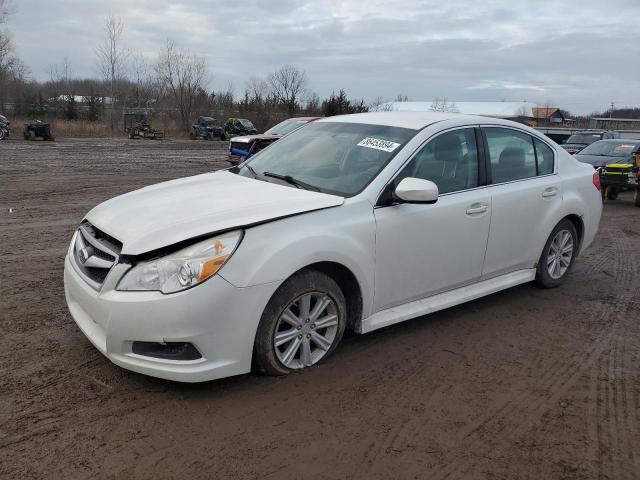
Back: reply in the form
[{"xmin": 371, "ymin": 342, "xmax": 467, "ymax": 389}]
[{"xmin": 0, "ymin": 9, "xmax": 369, "ymax": 132}]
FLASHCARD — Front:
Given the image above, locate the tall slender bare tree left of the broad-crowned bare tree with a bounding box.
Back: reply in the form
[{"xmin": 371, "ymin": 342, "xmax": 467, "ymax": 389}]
[{"xmin": 96, "ymin": 15, "xmax": 129, "ymax": 131}]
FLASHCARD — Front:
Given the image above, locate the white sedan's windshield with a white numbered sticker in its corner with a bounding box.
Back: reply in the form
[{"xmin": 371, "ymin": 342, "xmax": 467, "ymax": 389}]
[{"xmin": 239, "ymin": 122, "xmax": 417, "ymax": 197}]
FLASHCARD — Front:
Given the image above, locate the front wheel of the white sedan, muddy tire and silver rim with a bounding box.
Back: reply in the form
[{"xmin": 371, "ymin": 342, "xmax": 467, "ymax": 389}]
[{"xmin": 253, "ymin": 270, "xmax": 347, "ymax": 375}]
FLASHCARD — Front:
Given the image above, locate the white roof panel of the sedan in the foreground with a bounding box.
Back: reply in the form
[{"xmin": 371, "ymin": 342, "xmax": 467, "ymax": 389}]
[{"xmin": 318, "ymin": 112, "xmax": 526, "ymax": 130}]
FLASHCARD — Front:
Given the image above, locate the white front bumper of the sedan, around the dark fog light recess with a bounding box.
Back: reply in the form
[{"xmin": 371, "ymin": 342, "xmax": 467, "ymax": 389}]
[{"xmin": 64, "ymin": 256, "xmax": 277, "ymax": 382}]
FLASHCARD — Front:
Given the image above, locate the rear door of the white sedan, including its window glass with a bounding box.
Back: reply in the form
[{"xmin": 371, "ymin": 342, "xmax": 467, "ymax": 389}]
[{"xmin": 482, "ymin": 126, "xmax": 562, "ymax": 278}]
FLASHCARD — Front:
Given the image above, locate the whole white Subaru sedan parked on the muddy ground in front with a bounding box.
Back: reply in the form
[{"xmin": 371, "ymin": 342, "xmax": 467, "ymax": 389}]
[{"xmin": 64, "ymin": 112, "xmax": 602, "ymax": 382}]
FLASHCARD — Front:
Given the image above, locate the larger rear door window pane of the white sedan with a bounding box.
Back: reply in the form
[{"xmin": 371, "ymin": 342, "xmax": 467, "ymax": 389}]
[{"xmin": 484, "ymin": 128, "xmax": 537, "ymax": 183}]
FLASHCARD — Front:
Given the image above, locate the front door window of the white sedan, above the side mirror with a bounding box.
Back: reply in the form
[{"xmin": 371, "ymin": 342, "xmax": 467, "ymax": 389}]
[{"xmin": 394, "ymin": 128, "xmax": 478, "ymax": 193}]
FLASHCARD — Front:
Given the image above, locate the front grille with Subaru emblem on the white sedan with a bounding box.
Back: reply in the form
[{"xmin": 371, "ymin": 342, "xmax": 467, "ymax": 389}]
[{"xmin": 73, "ymin": 222, "xmax": 122, "ymax": 290}]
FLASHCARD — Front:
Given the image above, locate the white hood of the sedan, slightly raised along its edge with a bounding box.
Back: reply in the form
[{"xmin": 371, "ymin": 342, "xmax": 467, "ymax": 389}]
[{"xmin": 86, "ymin": 171, "xmax": 344, "ymax": 255}]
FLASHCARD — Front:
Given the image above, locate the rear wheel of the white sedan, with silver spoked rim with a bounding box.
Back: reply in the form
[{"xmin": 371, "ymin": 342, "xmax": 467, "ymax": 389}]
[{"xmin": 535, "ymin": 219, "xmax": 579, "ymax": 288}]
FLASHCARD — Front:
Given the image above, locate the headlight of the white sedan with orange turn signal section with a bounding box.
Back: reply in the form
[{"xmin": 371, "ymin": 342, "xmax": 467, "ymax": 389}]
[{"xmin": 116, "ymin": 230, "xmax": 242, "ymax": 293}]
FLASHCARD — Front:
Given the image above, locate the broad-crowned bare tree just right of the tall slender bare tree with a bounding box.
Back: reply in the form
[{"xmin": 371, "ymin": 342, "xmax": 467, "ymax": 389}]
[{"xmin": 155, "ymin": 40, "xmax": 208, "ymax": 132}]
